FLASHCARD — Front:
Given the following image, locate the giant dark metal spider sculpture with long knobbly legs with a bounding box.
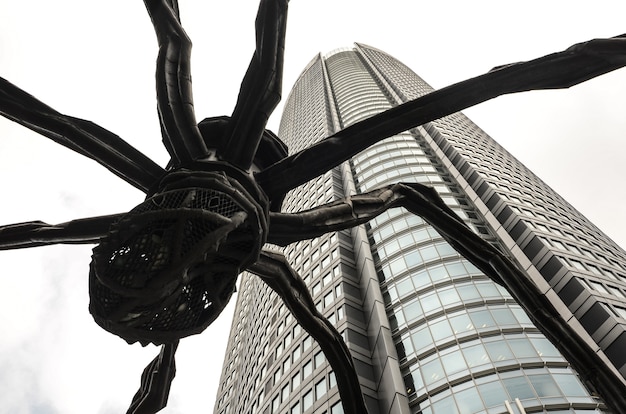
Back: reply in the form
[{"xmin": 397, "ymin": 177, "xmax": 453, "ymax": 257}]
[{"xmin": 0, "ymin": 0, "xmax": 626, "ymax": 414}]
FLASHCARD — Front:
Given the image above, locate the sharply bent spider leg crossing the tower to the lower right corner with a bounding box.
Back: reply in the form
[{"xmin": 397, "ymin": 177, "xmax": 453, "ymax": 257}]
[{"xmin": 268, "ymin": 183, "xmax": 626, "ymax": 412}]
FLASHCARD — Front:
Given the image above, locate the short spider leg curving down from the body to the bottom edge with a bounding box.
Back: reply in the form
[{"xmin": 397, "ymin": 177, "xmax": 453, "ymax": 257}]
[{"xmin": 248, "ymin": 250, "xmax": 367, "ymax": 414}]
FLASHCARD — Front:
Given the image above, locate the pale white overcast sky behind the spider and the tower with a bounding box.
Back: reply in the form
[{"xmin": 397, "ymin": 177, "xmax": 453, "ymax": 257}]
[{"xmin": 0, "ymin": 0, "xmax": 626, "ymax": 414}]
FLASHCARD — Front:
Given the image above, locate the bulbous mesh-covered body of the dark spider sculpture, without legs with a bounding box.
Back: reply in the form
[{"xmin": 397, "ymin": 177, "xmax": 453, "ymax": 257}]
[{"xmin": 89, "ymin": 171, "xmax": 267, "ymax": 344}]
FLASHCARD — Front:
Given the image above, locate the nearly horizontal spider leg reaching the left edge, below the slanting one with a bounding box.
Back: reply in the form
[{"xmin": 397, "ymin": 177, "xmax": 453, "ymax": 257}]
[{"xmin": 0, "ymin": 213, "xmax": 126, "ymax": 250}]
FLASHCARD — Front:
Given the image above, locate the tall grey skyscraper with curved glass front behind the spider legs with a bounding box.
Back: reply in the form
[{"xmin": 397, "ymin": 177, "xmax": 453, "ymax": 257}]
[{"xmin": 215, "ymin": 44, "xmax": 626, "ymax": 414}]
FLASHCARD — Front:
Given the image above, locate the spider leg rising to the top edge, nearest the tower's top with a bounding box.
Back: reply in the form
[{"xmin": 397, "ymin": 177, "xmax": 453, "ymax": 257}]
[{"xmin": 220, "ymin": 0, "xmax": 289, "ymax": 169}]
